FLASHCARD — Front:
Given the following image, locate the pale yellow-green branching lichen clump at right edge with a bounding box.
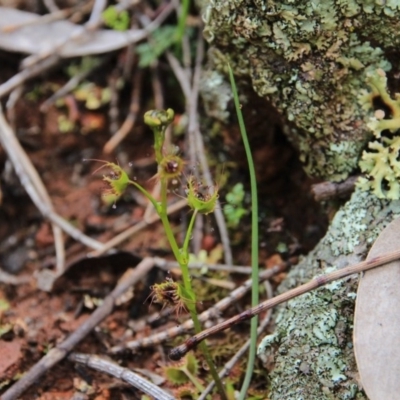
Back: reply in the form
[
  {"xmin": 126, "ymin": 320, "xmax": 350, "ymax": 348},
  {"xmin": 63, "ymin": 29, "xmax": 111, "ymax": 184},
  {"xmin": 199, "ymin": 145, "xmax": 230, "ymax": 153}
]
[{"xmin": 357, "ymin": 69, "xmax": 400, "ymax": 200}]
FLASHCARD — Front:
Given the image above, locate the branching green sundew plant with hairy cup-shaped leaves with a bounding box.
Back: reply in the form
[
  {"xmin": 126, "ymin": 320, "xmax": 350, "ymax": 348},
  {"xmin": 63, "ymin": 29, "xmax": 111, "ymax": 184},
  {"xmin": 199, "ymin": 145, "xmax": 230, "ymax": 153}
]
[{"xmin": 90, "ymin": 109, "xmax": 227, "ymax": 399}]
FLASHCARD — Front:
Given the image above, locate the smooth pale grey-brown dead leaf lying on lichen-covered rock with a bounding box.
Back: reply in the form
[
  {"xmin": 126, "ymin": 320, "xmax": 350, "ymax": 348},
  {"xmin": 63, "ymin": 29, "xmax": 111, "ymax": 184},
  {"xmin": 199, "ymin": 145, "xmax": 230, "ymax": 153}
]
[{"xmin": 354, "ymin": 218, "xmax": 400, "ymax": 400}]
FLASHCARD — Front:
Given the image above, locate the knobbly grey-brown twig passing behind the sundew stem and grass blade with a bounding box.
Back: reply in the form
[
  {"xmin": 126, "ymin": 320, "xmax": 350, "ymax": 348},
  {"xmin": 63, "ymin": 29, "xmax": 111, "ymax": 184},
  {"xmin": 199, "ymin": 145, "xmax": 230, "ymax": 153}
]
[{"xmin": 111, "ymin": 263, "xmax": 289, "ymax": 353}]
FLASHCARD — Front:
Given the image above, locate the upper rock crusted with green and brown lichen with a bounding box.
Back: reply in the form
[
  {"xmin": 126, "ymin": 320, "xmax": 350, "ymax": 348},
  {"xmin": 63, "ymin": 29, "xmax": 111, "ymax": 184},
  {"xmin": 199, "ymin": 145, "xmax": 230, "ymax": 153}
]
[{"xmin": 203, "ymin": 0, "xmax": 400, "ymax": 180}]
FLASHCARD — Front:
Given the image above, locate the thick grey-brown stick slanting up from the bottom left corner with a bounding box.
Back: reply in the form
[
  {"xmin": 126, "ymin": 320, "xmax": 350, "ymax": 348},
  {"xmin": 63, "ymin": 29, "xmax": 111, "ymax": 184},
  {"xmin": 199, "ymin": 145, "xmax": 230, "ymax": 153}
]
[{"xmin": 1, "ymin": 258, "xmax": 154, "ymax": 400}]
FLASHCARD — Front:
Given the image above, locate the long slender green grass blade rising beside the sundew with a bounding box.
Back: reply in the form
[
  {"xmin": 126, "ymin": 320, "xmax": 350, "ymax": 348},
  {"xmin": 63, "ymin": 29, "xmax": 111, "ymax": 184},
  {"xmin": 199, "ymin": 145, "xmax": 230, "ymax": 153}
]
[{"xmin": 228, "ymin": 64, "xmax": 259, "ymax": 400}]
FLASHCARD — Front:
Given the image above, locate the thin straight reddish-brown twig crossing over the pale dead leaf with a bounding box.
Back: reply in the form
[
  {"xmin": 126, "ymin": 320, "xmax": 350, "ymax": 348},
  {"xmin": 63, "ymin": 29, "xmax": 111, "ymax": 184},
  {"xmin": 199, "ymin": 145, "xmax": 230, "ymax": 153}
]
[{"xmin": 169, "ymin": 250, "xmax": 400, "ymax": 360}]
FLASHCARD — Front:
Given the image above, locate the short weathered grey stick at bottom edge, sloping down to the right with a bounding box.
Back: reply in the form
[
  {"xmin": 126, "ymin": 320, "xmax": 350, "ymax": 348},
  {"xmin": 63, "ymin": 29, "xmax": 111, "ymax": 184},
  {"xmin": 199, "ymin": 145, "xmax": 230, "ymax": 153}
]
[{"xmin": 68, "ymin": 353, "xmax": 175, "ymax": 400}]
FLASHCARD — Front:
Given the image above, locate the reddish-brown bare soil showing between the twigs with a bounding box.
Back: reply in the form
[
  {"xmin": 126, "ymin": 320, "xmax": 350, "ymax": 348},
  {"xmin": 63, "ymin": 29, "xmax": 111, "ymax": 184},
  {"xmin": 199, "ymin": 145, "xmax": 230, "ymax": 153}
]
[{"xmin": 0, "ymin": 54, "xmax": 326, "ymax": 400}]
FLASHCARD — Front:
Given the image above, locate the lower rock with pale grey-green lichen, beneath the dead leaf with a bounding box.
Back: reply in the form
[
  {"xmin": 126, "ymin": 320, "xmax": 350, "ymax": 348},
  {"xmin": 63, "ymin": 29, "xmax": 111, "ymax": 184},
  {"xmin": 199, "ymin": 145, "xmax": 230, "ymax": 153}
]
[{"xmin": 258, "ymin": 189, "xmax": 400, "ymax": 400}]
